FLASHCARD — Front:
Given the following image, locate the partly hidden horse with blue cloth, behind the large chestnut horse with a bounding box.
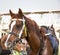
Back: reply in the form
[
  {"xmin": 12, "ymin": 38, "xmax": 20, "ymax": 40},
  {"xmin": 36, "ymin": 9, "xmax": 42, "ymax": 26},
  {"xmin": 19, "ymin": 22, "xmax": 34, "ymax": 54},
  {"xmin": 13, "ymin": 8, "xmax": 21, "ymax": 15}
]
[{"xmin": 41, "ymin": 25, "xmax": 59, "ymax": 55}]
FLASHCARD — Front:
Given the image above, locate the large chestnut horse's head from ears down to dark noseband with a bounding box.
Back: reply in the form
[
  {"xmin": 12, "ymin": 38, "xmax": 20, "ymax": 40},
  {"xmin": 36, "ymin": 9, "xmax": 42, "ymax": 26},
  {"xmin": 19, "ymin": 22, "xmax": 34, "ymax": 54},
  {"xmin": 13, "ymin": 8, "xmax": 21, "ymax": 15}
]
[{"xmin": 9, "ymin": 9, "xmax": 25, "ymax": 39}]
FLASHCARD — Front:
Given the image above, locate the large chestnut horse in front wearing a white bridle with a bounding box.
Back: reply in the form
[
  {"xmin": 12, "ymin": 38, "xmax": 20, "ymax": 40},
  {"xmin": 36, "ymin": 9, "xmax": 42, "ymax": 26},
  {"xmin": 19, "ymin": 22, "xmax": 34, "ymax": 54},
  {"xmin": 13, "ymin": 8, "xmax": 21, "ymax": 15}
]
[{"xmin": 3, "ymin": 8, "xmax": 53, "ymax": 55}]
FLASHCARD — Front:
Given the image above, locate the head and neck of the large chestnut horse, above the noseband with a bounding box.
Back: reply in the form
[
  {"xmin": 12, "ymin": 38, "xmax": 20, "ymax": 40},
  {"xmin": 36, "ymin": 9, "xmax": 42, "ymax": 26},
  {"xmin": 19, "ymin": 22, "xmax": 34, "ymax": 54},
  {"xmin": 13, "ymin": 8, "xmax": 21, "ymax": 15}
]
[{"xmin": 9, "ymin": 9, "xmax": 40, "ymax": 54}]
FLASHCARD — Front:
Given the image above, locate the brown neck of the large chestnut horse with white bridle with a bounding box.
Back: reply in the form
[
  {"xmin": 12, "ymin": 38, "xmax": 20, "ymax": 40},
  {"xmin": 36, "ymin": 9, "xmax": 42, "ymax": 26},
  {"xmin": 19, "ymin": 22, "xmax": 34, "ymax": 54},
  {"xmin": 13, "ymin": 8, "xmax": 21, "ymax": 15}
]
[{"xmin": 24, "ymin": 16, "xmax": 40, "ymax": 50}]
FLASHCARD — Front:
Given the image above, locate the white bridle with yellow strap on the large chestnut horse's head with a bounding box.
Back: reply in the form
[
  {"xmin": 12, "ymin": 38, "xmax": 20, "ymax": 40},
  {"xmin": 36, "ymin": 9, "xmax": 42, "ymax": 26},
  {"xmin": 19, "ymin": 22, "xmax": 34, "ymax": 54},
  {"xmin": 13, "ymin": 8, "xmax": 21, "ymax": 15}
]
[{"xmin": 5, "ymin": 17, "xmax": 27, "ymax": 48}]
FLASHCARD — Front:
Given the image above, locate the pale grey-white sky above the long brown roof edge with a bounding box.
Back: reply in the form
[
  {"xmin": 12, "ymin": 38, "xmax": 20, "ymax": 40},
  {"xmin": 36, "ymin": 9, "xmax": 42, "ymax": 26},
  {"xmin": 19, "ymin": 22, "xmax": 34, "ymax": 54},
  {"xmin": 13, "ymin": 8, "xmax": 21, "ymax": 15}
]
[{"xmin": 0, "ymin": 0, "xmax": 60, "ymax": 13}]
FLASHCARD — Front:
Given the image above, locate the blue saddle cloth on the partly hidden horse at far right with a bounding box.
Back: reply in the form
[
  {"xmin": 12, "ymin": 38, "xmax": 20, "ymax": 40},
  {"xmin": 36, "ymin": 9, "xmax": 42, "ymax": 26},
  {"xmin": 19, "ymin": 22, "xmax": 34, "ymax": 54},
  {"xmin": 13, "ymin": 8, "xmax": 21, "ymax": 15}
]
[{"xmin": 46, "ymin": 29, "xmax": 58, "ymax": 49}]
